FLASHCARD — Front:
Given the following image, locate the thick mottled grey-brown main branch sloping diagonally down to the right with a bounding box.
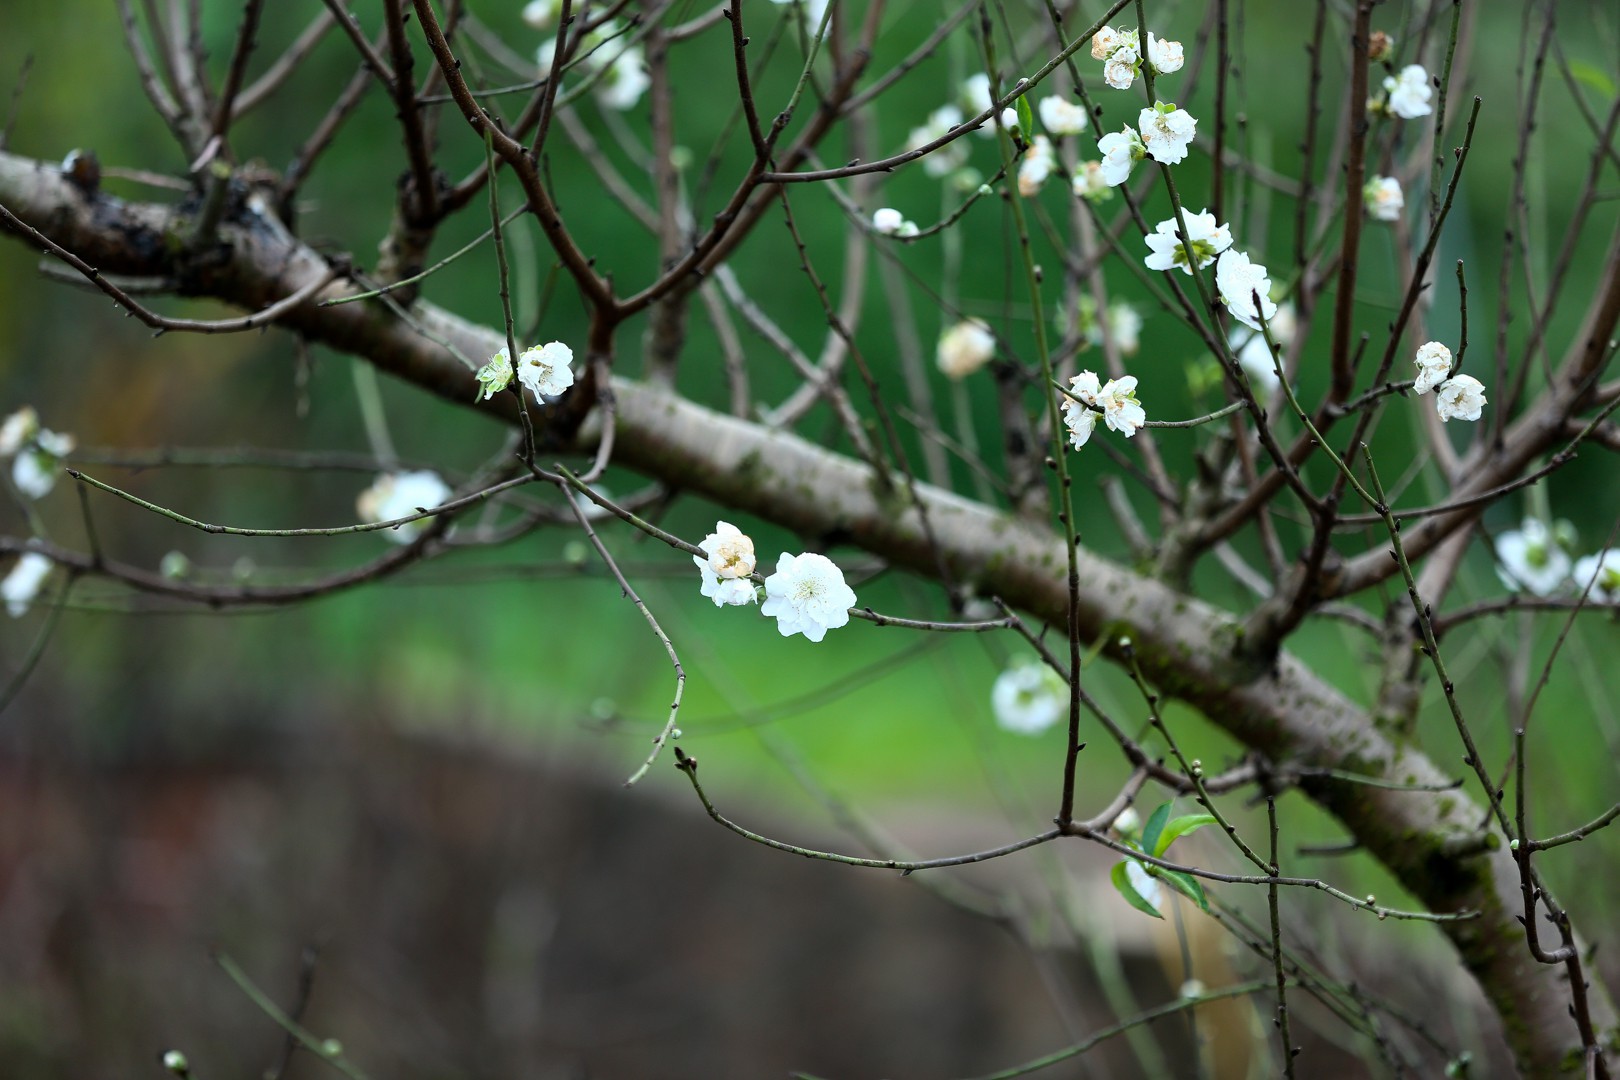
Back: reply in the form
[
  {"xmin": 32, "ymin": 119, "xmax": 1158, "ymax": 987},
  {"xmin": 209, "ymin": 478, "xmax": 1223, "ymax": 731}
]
[{"xmin": 0, "ymin": 154, "xmax": 1617, "ymax": 1077}]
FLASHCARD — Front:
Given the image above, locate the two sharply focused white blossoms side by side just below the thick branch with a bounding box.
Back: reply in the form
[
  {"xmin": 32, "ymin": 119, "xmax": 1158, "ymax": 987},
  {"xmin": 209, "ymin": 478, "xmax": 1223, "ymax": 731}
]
[{"xmin": 692, "ymin": 521, "xmax": 855, "ymax": 641}]
